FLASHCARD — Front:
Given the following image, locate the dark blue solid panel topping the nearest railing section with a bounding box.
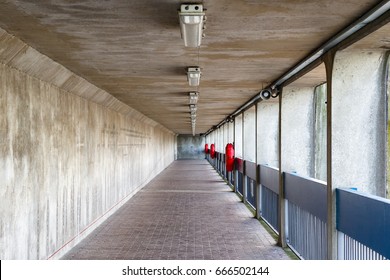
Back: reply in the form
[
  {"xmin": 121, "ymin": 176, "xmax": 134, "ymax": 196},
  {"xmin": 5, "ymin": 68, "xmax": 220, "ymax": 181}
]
[{"xmin": 336, "ymin": 189, "xmax": 390, "ymax": 259}]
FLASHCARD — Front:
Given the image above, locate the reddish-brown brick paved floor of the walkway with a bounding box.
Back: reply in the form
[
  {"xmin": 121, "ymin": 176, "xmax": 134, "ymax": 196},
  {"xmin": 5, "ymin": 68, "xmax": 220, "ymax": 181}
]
[{"xmin": 63, "ymin": 160, "xmax": 289, "ymax": 260}]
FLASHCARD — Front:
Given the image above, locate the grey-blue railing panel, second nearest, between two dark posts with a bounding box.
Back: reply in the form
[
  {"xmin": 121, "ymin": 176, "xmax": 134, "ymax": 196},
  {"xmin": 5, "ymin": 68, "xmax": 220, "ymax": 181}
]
[{"xmin": 283, "ymin": 173, "xmax": 327, "ymax": 222}]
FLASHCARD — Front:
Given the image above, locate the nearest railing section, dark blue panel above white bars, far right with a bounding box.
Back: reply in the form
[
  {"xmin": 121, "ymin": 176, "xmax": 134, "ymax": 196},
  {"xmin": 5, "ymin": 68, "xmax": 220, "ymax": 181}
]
[{"xmin": 336, "ymin": 189, "xmax": 390, "ymax": 260}]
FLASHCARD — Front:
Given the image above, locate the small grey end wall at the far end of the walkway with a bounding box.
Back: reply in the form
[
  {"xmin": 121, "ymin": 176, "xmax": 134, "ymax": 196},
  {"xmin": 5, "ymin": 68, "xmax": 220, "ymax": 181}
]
[{"xmin": 177, "ymin": 135, "xmax": 205, "ymax": 159}]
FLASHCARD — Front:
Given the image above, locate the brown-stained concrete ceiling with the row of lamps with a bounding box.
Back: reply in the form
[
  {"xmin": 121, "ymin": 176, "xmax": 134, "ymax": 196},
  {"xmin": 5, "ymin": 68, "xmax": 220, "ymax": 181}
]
[{"xmin": 0, "ymin": 0, "xmax": 390, "ymax": 134}]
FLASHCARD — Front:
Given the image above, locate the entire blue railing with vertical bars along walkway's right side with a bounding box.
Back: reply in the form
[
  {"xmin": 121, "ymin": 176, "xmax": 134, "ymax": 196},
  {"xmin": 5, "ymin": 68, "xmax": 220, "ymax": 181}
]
[{"xmin": 207, "ymin": 154, "xmax": 390, "ymax": 260}]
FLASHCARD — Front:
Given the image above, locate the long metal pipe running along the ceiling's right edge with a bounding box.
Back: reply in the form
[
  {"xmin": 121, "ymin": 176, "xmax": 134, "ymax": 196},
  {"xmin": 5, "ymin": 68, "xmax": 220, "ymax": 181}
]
[{"xmin": 204, "ymin": 0, "xmax": 390, "ymax": 135}]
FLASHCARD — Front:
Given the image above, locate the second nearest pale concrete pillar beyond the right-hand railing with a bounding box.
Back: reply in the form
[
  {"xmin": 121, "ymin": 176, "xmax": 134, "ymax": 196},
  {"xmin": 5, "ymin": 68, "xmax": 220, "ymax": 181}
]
[{"xmin": 281, "ymin": 87, "xmax": 314, "ymax": 177}]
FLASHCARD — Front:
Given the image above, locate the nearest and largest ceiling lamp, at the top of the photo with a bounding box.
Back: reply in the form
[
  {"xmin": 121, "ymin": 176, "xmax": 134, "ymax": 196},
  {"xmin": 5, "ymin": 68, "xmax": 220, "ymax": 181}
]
[{"xmin": 179, "ymin": 4, "xmax": 205, "ymax": 48}]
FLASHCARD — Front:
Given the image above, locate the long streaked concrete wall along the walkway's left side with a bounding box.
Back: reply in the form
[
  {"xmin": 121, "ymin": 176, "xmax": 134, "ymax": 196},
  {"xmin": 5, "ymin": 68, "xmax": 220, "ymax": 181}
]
[{"xmin": 0, "ymin": 29, "xmax": 175, "ymax": 259}]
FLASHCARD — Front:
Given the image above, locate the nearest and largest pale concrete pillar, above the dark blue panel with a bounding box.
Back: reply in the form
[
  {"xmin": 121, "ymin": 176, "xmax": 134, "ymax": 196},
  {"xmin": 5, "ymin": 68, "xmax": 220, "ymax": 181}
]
[{"xmin": 332, "ymin": 51, "xmax": 387, "ymax": 197}]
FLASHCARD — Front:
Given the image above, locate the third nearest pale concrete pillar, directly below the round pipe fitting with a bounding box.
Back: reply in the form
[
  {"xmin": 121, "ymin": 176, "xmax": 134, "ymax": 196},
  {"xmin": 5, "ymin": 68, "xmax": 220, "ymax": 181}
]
[{"xmin": 257, "ymin": 101, "xmax": 279, "ymax": 167}]
